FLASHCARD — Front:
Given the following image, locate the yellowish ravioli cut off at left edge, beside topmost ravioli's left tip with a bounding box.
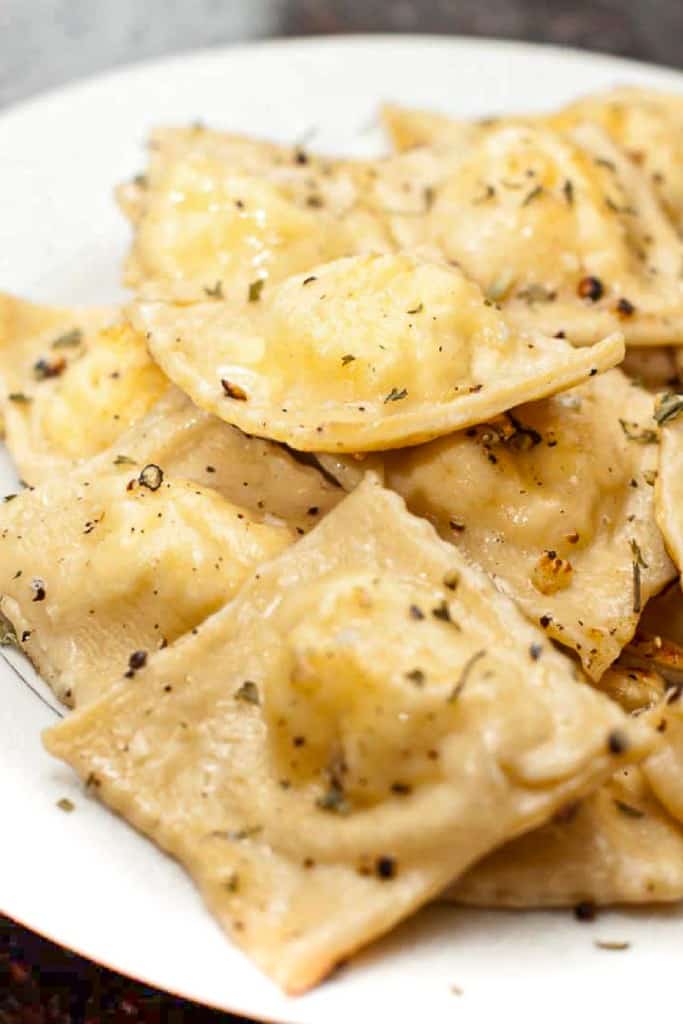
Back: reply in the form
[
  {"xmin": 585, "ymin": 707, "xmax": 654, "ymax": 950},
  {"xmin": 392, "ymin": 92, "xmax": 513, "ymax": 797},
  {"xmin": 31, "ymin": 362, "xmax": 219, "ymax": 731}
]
[{"xmin": 0, "ymin": 298, "xmax": 169, "ymax": 483}]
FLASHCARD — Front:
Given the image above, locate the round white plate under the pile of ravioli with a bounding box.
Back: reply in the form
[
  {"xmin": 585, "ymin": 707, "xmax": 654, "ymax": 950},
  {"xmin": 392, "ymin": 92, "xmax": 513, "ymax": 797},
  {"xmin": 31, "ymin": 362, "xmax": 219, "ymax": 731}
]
[{"xmin": 0, "ymin": 37, "xmax": 683, "ymax": 1024}]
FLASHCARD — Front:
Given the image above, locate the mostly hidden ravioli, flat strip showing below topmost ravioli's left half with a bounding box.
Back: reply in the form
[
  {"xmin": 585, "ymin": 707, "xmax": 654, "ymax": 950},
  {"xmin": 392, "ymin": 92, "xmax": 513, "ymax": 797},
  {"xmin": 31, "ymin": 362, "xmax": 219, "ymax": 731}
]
[{"xmin": 90, "ymin": 387, "xmax": 343, "ymax": 534}]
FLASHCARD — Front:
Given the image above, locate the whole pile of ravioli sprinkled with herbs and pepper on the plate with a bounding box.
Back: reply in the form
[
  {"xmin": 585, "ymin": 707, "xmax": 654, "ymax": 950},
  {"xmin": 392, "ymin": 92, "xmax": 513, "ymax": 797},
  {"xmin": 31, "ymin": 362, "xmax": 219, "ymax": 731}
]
[{"xmin": 0, "ymin": 89, "xmax": 683, "ymax": 992}]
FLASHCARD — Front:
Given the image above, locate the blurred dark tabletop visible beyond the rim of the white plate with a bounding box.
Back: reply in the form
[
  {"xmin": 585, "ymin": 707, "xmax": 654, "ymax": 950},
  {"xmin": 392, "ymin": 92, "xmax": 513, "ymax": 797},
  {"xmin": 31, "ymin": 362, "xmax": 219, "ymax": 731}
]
[{"xmin": 0, "ymin": 0, "xmax": 683, "ymax": 1024}]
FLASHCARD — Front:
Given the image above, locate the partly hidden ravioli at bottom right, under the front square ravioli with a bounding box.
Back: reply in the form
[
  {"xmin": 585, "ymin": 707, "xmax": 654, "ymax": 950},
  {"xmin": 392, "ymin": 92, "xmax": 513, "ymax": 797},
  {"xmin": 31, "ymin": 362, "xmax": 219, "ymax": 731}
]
[{"xmin": 447, "ymin": 766, "xmax": 683, "ymax": 907}]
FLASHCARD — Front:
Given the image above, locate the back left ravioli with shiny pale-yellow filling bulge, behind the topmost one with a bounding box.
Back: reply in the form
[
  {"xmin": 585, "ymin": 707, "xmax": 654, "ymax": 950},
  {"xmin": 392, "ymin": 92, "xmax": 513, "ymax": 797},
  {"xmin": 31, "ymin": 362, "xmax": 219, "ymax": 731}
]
[{"xmin": 119, "ymin": 128, "xmax": 391, "ymax": 302}]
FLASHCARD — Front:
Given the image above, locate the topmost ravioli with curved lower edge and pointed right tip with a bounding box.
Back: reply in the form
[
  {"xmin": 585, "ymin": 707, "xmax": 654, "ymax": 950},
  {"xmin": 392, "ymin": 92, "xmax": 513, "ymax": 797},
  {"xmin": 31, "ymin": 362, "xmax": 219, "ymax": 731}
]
[{"xmin": 132, "ymin": 254, "xmax": 624, "ymax": 452}]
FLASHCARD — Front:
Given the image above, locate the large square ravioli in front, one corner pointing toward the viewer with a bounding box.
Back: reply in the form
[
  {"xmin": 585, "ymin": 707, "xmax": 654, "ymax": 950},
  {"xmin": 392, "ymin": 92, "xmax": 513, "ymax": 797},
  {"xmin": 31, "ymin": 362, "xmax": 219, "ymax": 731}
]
[{"xmin": 45, "ymin": 477, "xmax": 651, "ymax": 992}]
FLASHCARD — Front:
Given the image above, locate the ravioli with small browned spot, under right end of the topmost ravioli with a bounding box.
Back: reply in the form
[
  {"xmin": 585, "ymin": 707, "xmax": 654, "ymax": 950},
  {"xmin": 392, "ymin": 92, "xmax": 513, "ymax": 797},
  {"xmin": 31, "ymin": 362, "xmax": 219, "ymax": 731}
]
[{"xmin": 323, "ymin": 370, "xmax": 676, "ymax": 679}]
